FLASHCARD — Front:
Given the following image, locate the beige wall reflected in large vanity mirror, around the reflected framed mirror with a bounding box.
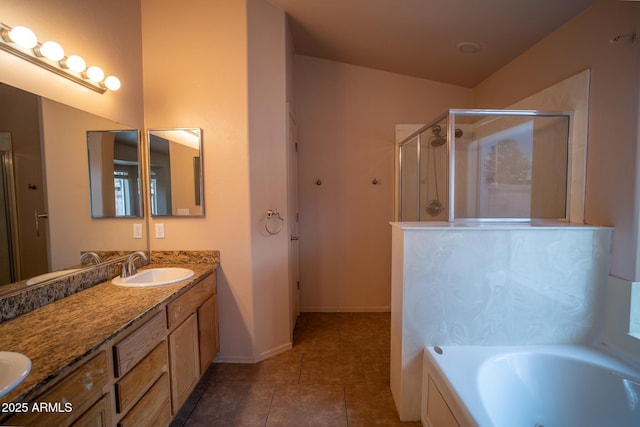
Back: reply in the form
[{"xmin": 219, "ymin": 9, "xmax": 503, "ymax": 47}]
[{"xmin": 42, "ymin": 99, "xmax": 146, "ymax": 269}]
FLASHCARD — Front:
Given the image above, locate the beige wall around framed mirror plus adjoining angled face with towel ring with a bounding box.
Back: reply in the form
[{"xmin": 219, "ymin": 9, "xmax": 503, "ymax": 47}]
[{"xmin": 142, "ymin": 0, "xmax": 291, "ymax": 362}]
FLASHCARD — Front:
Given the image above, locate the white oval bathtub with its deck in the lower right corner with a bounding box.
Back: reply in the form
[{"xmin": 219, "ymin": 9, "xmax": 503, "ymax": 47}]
[{"xmin": 421, "ymin": 345, "xmax": 640, "ymax": 427}]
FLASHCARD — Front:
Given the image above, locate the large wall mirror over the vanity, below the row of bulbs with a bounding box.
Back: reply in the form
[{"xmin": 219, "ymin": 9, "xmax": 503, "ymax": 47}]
[{"xmin": 0, "ymin": 83, "xmax": 148, "ymax": 295}]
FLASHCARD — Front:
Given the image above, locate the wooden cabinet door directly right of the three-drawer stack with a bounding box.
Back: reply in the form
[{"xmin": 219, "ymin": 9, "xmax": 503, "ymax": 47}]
[{"xmin": 169, "ymin": 313, "xmax": 200, "ymax": 415}]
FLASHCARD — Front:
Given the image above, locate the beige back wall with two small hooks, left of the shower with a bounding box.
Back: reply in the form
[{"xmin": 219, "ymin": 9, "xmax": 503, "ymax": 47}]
[{"xmin": 295, "ymin": 56, "xmax": 471, "ymax": 311}]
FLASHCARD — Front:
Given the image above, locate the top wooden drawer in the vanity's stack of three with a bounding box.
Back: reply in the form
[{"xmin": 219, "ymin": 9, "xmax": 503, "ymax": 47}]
[{"xmin": 113, "ymin": 310, "xmax": 167, "ymax": 378}]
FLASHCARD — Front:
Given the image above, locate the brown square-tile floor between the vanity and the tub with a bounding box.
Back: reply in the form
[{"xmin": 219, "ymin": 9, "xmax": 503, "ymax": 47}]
[{"xmin": 171, "ymin": 313, "xmax": 421, "ymax": 427}]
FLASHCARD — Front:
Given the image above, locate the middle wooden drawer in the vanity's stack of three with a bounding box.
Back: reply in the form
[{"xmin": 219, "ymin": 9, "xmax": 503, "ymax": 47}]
[{"xmin": 116, "ymin": 340, "xmax": 168, "ymax": 413}]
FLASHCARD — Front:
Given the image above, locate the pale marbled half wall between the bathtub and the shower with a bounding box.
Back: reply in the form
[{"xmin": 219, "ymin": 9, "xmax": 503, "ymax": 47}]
[{"xmin": 391, "ymin": 223, "xmax": 613, "ymax": 420}]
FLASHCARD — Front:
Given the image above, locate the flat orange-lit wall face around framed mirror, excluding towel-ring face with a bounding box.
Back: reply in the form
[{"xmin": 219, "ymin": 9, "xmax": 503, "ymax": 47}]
[{"xmin": 142, "ymin": 0, "xmax": 254, "ymax": 360}]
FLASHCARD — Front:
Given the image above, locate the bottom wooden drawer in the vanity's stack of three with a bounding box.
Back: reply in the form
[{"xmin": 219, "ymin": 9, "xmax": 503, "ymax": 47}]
[{"xmin": 118, "ymin": 372, "xmax": 171, "ymax": 427}]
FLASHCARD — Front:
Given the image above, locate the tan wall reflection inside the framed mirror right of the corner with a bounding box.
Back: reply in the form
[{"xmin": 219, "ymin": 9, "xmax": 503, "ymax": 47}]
[{"xmin": 169, "ymin": 142, "xmax": 200, "ymax": 215}]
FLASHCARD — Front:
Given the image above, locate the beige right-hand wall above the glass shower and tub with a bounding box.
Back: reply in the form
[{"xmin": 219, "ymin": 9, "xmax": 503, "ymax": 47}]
[{"xmin": 474, "ymin": 0, "xmax": 640, "ymax": 279}]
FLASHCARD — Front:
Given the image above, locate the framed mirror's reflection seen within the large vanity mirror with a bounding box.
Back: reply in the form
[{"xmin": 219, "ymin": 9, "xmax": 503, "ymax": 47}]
[{"xmin": 87, "ymin": 130, "xmax": 142, "ymax": 218}]
